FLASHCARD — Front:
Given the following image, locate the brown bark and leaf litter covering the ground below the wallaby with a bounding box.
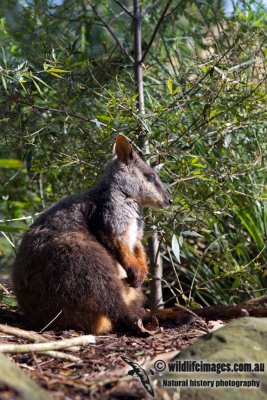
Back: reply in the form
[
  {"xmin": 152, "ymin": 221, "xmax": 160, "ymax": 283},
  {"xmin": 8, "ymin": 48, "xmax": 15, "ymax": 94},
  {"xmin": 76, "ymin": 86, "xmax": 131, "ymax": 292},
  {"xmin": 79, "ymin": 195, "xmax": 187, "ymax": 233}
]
[{"xmin": 0, "ymin": 303, "xmax": 218, "ymax": 400}]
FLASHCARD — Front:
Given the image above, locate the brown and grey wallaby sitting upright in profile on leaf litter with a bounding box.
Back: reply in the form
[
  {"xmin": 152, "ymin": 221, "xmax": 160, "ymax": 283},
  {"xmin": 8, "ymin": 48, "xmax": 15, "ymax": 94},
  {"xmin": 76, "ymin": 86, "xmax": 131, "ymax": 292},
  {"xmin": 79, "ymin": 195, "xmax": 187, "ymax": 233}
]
[{"xmin": 13, "ymin": 134, "xmax": 171, "ymax": 333}]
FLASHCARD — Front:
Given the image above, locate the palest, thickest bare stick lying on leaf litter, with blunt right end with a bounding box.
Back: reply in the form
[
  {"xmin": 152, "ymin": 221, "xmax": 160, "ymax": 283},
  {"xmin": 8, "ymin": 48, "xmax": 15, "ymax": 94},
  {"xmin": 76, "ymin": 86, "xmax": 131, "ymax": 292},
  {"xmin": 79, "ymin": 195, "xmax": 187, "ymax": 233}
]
[{"xmin": 0, "ymin": 335, "xmax": 95, "ymax": 354}]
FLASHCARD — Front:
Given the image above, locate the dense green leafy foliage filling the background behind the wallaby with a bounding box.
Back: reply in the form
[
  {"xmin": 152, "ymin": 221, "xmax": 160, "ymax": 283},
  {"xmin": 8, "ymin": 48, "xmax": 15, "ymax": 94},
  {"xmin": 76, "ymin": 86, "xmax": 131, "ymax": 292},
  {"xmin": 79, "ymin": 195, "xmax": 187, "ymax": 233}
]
[{"xmin": 0, "ymin": 0, "xmax": 267, "ymax": 304}]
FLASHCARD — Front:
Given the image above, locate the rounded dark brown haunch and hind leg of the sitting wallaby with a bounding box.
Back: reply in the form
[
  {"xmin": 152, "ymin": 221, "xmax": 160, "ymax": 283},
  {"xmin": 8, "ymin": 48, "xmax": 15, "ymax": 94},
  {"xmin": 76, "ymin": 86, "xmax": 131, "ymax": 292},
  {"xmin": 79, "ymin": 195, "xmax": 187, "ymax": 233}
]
[{"xmin": 13, "ymin": 232, "xmax": 142, "ymax": 333}]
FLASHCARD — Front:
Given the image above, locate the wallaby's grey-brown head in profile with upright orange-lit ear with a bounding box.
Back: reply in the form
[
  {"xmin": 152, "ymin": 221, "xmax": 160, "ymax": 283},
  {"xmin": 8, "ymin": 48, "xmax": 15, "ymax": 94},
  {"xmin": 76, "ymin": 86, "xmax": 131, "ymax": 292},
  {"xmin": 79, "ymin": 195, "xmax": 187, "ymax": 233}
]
[{"xmin": 105, "ymin": 134, "xmax": 172, "ymax": 208}]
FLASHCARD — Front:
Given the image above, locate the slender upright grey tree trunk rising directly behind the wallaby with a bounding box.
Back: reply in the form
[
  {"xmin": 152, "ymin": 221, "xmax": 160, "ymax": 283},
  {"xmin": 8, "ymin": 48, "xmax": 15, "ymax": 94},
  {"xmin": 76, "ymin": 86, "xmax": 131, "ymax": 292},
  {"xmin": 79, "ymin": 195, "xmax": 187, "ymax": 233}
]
[{"xmin": 133, "ymin": 0, "xmax": 163, "ymax": 310}]
